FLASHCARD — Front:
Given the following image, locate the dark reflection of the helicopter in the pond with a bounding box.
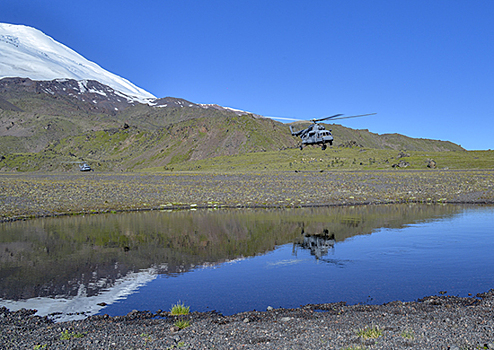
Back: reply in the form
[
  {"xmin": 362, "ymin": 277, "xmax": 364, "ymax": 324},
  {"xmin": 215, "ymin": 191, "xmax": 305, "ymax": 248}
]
[{"xmin": 293, "ymin": 229, "xmax": 341, "ymax": 265}]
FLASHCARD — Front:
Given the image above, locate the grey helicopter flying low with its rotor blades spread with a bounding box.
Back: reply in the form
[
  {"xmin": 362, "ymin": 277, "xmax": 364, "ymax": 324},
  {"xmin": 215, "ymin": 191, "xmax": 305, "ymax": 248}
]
[{"xmin": 290, "ymin": 113, "xmax": 376, "ymax": 151}]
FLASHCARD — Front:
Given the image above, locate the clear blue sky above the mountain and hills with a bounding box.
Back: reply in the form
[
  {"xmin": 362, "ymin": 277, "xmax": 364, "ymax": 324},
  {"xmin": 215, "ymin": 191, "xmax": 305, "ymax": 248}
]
[{"xmin": 0, "ymin": 0, "xmax": 494, "ymax": 150}]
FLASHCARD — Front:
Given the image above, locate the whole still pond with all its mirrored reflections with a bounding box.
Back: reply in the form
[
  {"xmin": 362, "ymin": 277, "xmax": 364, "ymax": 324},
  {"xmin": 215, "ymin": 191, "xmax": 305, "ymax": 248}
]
[{"xmin": 0, "ymin": 205, "xmax": 494, "ymax": 320}]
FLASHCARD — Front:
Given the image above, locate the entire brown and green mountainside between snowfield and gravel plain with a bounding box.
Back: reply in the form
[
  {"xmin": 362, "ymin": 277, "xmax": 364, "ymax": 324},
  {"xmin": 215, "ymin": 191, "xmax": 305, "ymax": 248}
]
[{"xmin": 0, "ymin": 78, "xmax": 480, "ymax": 171}]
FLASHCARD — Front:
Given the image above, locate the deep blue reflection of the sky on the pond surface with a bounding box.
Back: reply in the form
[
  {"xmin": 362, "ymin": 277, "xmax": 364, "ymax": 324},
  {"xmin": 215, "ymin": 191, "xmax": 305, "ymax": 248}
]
[{"xmin": 107, "ymin": 208, "xmax": 494, "ymax": 315}]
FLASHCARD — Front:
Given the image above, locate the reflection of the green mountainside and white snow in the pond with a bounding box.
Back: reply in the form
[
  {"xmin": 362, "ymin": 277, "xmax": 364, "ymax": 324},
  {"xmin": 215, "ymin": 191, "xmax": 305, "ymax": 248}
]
[{"xmin": 0, "ymin": 205, "xmax": 492, "ymax": 318}]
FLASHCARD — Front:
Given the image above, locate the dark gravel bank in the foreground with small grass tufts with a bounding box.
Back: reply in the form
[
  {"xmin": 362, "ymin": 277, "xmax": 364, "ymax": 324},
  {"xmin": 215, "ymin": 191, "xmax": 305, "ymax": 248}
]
[{"xmin": 0, "ymin": 290, "xmax": 494, "ymax": 350}]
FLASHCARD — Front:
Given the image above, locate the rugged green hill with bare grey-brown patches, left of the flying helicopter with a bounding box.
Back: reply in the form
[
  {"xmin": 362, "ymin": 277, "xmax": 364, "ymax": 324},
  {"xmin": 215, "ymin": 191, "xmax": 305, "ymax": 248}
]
[{"xmin": 0, "ymin": 115, "xmax": 296, "ymax": 171}]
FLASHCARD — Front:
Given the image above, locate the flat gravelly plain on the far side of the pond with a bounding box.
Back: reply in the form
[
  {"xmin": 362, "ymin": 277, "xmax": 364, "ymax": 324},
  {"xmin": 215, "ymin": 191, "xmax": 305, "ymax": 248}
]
[{"xmin": 0, "ymin": 170, "xmax": 494, "ymax": 221}]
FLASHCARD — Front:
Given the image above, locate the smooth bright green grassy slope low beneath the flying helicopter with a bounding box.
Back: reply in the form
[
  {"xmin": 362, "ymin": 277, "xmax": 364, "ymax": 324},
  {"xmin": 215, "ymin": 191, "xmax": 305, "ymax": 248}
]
[{"xmin": 140, "ymin": 147, "xmax": 494, "ymax": 172}]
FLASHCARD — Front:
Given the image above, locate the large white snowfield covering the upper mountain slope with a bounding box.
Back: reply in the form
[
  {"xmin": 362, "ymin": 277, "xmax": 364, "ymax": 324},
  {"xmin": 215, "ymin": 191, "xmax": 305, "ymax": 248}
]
[{"xmin": 0, "ymin": 23, "xmax": 156, "ymax": 103}]
